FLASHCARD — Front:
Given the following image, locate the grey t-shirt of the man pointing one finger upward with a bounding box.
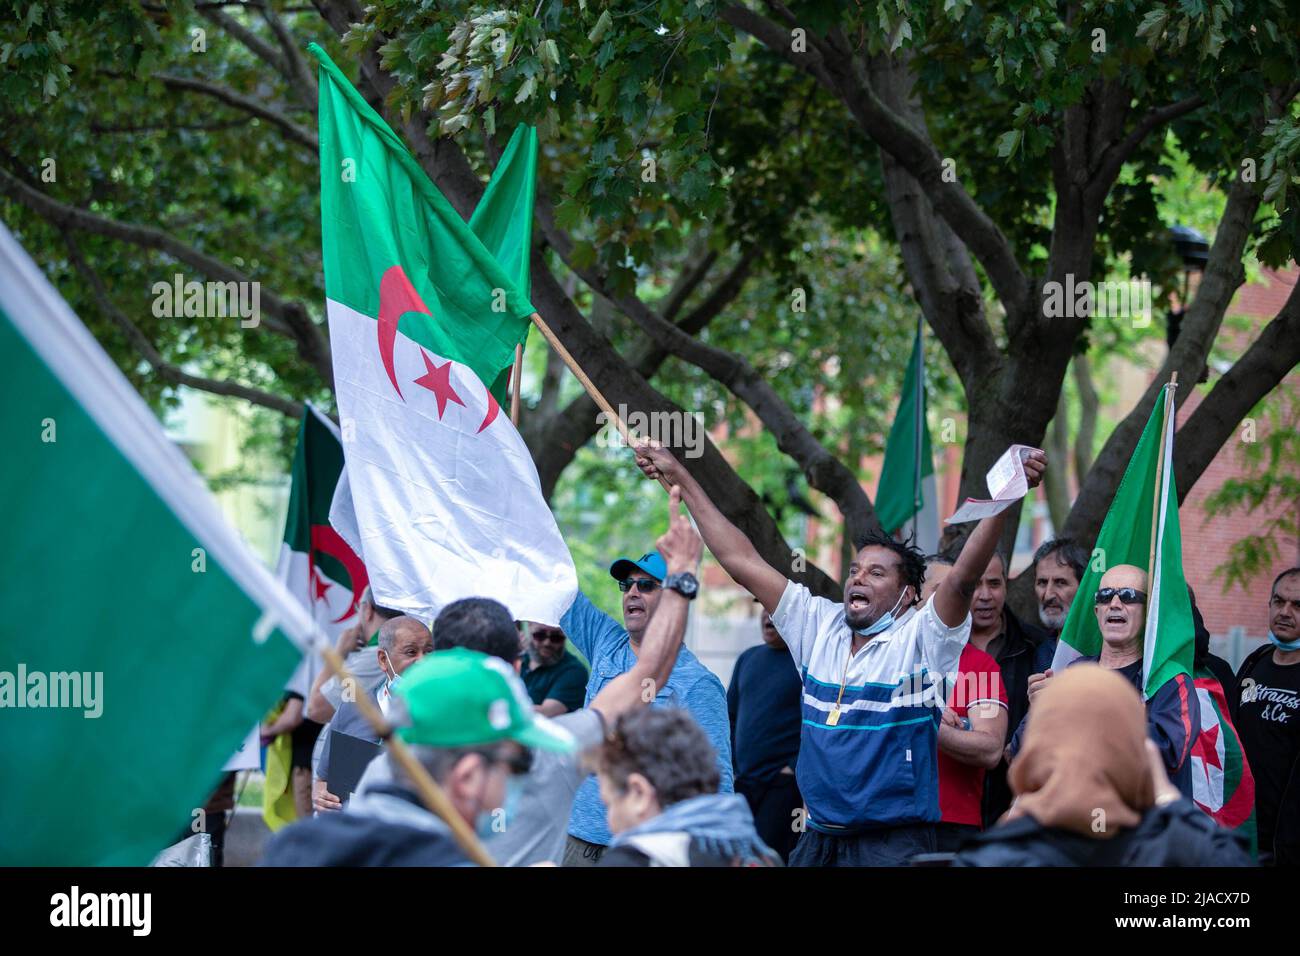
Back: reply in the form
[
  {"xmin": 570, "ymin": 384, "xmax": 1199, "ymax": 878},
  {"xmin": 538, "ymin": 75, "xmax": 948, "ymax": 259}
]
[{"xmin": 484, "ymin": 709, "xmax": 605, "ymax": 866}]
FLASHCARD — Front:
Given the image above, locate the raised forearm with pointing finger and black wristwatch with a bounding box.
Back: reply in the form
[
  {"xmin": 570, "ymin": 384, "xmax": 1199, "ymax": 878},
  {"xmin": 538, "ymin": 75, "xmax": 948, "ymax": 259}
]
[{"xmin": 589, "ymin": 485, "xmax": 703, "ymax": 724}]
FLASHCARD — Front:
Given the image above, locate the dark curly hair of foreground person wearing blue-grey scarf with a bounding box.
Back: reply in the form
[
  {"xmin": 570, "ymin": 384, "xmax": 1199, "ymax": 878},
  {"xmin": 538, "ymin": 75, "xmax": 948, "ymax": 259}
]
[{"xmin": 595, "ymin": 708, "xmax": 720, "ymax": 806}]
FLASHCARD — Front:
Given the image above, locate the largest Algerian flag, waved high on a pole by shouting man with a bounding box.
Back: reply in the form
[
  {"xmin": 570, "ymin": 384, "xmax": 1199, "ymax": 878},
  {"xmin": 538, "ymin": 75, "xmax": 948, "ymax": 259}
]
[{"xmin": 311, "ymin": 44, "xmax": 577, "ymax": 624}]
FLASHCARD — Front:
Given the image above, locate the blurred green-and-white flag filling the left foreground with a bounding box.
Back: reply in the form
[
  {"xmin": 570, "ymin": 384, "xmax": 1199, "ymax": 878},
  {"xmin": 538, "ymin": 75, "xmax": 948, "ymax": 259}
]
[{"xmin": 0, "ymin": 226, "xmax": 311, "ymax": 866}]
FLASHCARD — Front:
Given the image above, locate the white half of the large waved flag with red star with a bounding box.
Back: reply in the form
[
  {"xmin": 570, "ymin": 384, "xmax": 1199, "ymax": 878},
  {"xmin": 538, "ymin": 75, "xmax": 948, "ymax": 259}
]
[{"xmin": 328, "ymin": 300, "xmax": 577, "ymax": 624}]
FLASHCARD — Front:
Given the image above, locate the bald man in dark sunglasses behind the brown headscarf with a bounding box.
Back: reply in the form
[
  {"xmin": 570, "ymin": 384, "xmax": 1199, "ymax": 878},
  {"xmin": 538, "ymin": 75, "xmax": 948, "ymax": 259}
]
[{"xmin": 1008, "ymin": 564, "xmax": 1201, "ymax": 799}]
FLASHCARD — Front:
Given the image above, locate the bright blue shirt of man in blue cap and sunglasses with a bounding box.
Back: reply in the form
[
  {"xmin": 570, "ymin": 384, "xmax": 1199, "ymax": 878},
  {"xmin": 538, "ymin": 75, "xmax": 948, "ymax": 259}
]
[{"xmin": 560, "ymin": 592, "xmax": 733, "ymax": 845}]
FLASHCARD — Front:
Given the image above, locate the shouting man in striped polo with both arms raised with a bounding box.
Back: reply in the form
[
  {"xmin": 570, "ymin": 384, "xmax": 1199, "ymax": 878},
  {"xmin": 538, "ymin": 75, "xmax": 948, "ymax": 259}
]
[{"xmin": 637, "ymin": 445, "xmax": 1047, "ymax": 866}]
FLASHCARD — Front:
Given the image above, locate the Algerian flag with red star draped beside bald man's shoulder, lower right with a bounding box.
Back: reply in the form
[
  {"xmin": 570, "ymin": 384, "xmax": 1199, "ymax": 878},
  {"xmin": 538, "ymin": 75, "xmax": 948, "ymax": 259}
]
[{"xmin": 1192, "ymin": 667, "xmax": 1257, "ymax": 853}]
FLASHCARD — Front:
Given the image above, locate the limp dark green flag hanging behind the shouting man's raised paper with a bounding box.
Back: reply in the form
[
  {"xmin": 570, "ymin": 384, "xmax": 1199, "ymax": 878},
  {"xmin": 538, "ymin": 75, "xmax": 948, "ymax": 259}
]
[{"xmin": 876, "ymin": 321, "xmax": 939, "ymax": 554}]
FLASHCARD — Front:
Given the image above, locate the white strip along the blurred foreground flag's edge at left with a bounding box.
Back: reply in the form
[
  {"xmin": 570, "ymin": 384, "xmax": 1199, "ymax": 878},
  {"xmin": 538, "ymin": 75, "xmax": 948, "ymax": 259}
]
[{"xmin": 0, "ymin": 224, "xmax": 312, "ymax": 658}]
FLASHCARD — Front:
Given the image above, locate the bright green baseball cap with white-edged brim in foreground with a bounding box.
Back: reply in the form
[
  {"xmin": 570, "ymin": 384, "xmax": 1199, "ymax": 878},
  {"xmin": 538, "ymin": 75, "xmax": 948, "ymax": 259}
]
[{"xmin": 393, "ymin": 648, "xmax": 577, "ymax": 753}]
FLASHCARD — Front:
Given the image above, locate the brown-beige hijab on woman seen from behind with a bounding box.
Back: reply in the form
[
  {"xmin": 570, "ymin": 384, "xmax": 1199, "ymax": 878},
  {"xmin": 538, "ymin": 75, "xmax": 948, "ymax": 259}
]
[{"xmin": 1002, "ymin": 663, "xmax": 1154, "ymax": 840}]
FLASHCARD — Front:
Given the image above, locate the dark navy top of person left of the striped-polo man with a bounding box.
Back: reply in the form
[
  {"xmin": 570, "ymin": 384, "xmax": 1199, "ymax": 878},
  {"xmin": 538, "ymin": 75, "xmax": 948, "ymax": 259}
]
[{"xmin": 727, "ymin": 644, "xmax": 803, "ymax": 784}]
